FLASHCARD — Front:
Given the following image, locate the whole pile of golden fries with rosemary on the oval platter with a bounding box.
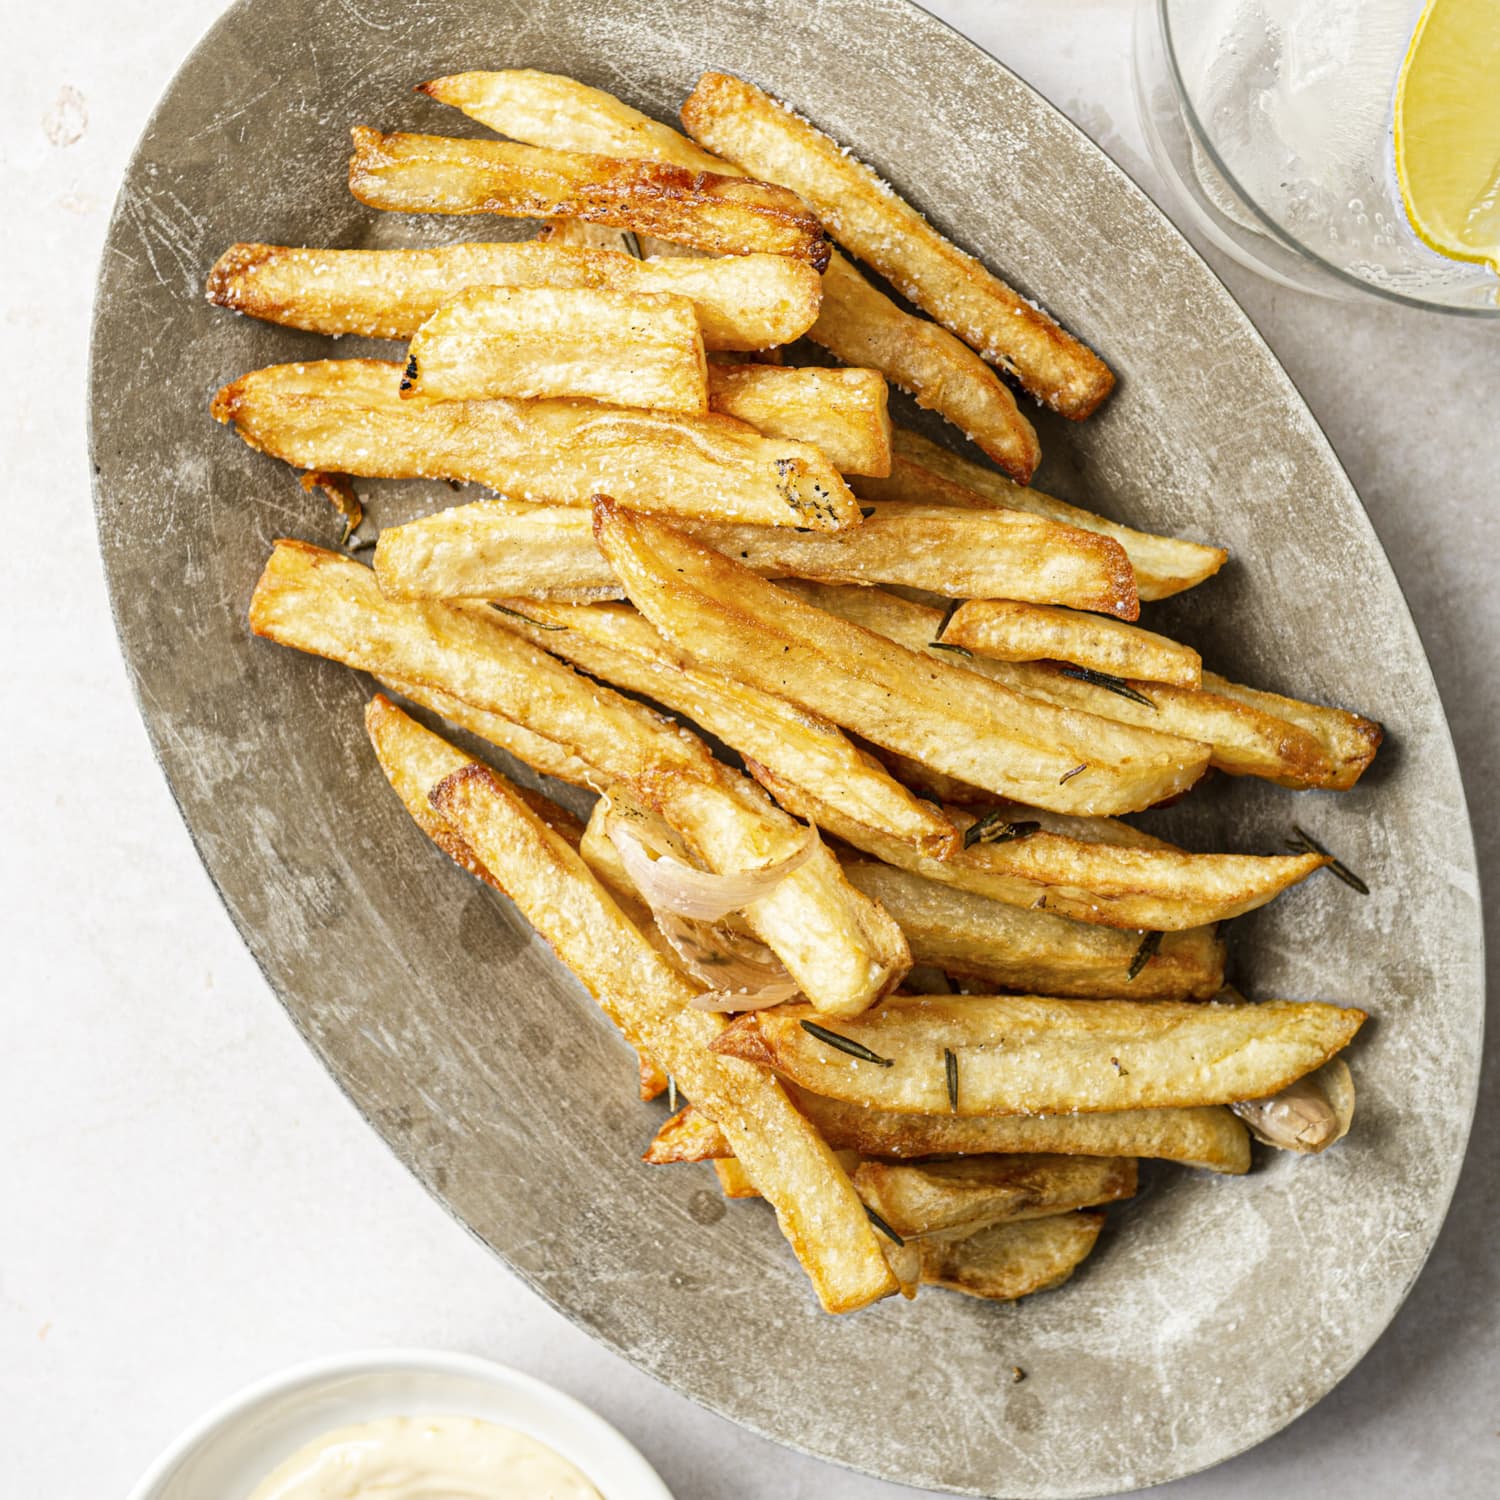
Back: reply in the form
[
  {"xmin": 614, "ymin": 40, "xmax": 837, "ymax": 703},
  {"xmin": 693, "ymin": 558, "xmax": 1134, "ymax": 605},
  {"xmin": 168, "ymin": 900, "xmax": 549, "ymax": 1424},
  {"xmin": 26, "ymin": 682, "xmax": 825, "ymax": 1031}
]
[{"xmin": 209, "ymin": 71, "xmax": 1380, "ymax": 1313}]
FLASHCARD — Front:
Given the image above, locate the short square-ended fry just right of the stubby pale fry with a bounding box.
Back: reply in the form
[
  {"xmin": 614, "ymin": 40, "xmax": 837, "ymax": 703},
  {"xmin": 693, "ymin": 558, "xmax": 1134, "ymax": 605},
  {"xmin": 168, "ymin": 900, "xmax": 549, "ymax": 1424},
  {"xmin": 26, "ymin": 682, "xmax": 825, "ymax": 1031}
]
[{"xmin": 708, "ymin": 365, "xmax": 891, "ymax": 474}]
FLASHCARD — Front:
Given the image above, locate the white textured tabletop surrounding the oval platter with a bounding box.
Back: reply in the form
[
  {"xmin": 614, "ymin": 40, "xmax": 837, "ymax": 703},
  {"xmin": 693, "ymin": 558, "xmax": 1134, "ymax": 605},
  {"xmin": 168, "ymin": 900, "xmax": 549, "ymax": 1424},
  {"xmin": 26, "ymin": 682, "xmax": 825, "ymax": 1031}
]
[{"xmin": 0, "ymin": 0, "xmax": 1500, "ymax": 1500}]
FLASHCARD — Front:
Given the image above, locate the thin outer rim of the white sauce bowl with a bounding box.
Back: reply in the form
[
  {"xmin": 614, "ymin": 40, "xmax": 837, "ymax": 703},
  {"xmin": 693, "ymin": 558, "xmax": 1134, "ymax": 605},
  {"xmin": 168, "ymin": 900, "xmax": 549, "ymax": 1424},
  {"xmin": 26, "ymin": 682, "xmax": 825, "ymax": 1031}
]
[{"xmin": 126, "ymin": 1346, "xmax": 672, "ymax": 1500}]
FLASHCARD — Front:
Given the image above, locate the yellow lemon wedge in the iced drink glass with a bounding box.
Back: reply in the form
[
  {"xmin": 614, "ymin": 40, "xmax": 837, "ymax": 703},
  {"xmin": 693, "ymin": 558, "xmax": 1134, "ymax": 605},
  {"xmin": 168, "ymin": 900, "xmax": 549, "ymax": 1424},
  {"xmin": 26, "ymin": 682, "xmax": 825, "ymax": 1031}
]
[{"xmin": 1395, "ymin": 0, "xmax": 1500, "ymax": 273}]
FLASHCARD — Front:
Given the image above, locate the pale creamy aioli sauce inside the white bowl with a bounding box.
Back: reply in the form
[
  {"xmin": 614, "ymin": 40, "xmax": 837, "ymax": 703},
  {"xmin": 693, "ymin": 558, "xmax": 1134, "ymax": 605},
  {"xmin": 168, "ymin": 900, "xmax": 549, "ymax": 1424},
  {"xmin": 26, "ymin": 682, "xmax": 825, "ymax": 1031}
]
[{"xmin": 251, "ymin": 1416, "xmax": 602, "ymax": 1500}]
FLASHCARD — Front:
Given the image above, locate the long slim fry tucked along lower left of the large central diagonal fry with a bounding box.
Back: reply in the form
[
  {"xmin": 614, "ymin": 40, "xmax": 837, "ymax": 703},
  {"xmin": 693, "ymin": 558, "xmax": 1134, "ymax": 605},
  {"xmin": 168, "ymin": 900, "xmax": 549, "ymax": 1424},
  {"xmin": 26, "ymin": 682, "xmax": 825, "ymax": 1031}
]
[{"xmin": 507, "ymin": 600, "xmax": 959, "ymax": 858}]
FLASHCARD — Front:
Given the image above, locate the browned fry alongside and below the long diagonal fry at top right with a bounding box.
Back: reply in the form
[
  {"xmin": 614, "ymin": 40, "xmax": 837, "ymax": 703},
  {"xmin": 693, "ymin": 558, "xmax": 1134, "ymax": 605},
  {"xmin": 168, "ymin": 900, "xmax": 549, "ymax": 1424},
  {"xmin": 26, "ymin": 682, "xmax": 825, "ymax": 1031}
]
[{"xmin": 807, "ymin": 254, "xmax": 1041, "ymax": 485}]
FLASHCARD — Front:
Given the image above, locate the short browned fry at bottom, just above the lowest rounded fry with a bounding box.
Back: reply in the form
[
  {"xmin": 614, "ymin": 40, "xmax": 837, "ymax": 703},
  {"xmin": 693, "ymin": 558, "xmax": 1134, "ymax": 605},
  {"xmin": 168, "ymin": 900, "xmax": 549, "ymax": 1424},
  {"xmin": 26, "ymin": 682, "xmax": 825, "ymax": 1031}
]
[{"xmin": 854, "ymin": 1154, "xmax": 1136, "ymax": 1239}]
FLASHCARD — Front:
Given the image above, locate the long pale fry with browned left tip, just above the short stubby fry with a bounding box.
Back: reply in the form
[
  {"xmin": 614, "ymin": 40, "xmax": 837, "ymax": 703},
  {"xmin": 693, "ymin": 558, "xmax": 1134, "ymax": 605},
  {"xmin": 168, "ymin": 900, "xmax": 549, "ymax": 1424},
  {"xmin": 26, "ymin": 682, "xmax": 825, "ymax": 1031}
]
[{"xmin": 209, "ymin": 244, "xmax": 822, "ymax": 350}]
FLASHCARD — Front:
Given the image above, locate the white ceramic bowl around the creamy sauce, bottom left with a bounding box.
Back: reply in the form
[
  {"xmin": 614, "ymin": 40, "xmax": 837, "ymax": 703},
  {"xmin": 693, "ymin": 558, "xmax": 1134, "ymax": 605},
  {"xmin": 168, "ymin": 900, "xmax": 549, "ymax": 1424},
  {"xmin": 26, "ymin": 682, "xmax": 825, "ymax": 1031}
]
[{"xmin": 129, "ymin": 1349, "xmax": 672, "ymax": 1500}]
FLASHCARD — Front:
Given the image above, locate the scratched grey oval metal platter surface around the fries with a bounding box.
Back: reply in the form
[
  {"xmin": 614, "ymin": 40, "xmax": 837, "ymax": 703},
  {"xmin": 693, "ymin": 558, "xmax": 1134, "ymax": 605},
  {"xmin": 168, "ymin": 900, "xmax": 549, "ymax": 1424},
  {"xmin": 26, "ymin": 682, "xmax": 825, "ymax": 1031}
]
[{"xmin": 92, "ymin": 0, "xmax": 1482, "ymax": 1496}]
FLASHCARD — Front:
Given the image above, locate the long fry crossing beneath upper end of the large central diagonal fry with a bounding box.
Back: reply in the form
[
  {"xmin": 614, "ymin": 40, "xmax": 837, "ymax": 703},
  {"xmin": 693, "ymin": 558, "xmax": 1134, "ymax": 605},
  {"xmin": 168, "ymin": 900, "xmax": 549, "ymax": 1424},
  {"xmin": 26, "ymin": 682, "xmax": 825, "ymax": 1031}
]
[{"xmin": 375, "ymin": 501, "xmax": 1134, "ymax": 609}]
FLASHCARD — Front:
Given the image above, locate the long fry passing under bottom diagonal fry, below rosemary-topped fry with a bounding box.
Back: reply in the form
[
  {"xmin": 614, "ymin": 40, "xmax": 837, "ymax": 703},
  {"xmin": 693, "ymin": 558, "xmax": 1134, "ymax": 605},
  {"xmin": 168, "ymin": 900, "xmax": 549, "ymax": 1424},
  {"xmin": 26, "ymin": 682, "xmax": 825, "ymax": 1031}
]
[{"xmin": 642, "ymin": 1085, "xmax": 1250, "ymax": 1176}]
